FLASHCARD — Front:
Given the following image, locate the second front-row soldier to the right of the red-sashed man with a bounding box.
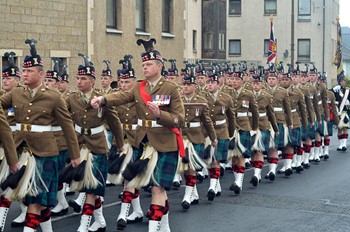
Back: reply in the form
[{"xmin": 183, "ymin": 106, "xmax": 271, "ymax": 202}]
[{"xmin": 200, "ymin": 73, "xmax": 235, "ymax": 201}]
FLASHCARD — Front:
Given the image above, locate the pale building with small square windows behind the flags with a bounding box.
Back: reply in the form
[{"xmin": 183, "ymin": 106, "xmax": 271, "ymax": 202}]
[{"xmin": 227, "ymin": 0, "xmax": 339, "ymax": 85}]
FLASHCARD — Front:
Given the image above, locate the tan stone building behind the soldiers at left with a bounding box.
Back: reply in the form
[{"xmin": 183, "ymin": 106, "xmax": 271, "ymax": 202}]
[{"xmin": 0, "ymin": 0, "xmax": 185, "ymax": 89}]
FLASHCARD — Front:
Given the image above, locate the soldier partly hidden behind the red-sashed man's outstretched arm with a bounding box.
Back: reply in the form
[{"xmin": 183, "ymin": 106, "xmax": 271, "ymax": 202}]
[{"xmin": 117, "ymin": 61, "xmax": 143, "ymax": 230}]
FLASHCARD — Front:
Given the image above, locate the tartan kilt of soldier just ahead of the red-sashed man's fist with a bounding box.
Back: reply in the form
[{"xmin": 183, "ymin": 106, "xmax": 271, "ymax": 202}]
[{"xmin": 81, "ymin": 153, "xmax": 108, "ymax": 196}]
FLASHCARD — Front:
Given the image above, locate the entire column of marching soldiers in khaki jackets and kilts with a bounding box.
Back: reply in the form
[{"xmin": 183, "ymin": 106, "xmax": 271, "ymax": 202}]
[{"xmin": 0, "ymin": 39, "xmax": 350, "ymax": 232}]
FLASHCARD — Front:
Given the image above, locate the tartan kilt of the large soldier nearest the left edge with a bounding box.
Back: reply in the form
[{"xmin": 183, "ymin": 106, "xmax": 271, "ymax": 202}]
[{"xmin": 24, "ymin": 155, "xmax": 59, "ymax": 207}]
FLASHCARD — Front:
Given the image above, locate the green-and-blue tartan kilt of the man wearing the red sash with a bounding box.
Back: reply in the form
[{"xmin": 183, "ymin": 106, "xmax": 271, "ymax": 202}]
[{"xmin": 152, "ymin": 151, "xmax": 179, "ymax": 191}]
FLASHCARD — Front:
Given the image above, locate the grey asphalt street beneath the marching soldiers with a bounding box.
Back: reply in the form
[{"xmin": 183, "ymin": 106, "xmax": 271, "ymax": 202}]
[{"xmin": 5, "ymin": 135, "xmax": 350, "ymax": 232}]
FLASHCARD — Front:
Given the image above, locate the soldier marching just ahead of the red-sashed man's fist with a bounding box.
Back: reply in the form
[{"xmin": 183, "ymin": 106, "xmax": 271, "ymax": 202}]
[{"xmin": 66, "ymin": 54, "xmax": 123, "ymax": 232}]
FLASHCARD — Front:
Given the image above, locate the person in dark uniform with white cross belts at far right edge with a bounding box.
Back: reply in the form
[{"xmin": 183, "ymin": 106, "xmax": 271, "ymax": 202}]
[{"xmin": 333, "ymin": 77, "xmax": 350, "ymax": 151}]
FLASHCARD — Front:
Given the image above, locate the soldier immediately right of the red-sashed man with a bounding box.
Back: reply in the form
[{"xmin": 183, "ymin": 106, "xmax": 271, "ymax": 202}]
[{"xmin": 182, "ymin": 71, "xmax": 217, "ymax": 209}]
